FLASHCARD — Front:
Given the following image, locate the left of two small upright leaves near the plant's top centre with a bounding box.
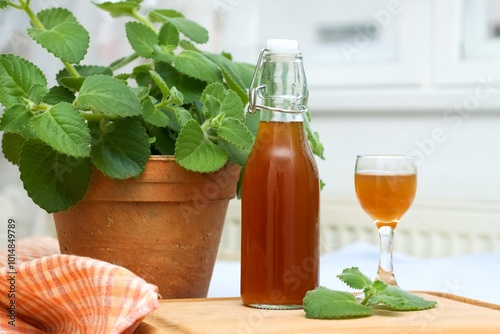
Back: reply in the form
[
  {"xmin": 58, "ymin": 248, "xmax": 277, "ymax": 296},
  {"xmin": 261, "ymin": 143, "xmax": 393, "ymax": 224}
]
[{"xmin": 125, "ymin": 22, "xmax": 159, "ymax": 58}]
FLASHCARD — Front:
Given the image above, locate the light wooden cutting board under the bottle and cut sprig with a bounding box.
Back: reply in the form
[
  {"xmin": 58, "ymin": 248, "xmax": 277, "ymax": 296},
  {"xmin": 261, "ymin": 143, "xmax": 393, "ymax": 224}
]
[{"xmin": 136, "ymin": 292, "xmax": 500, "ymax": 334}]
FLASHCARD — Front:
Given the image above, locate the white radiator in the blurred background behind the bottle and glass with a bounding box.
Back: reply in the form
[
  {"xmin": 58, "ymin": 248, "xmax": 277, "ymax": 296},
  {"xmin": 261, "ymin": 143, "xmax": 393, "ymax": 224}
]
[{"xmin": 218, "ymin": 196, "xmax": 500, "ymax": 260}]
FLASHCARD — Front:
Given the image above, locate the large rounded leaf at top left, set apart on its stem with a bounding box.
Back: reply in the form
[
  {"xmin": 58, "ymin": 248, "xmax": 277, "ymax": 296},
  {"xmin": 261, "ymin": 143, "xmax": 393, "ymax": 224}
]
[{"xmin": 28, "ymin": 8, "xmax": 90, "ymax": 64}]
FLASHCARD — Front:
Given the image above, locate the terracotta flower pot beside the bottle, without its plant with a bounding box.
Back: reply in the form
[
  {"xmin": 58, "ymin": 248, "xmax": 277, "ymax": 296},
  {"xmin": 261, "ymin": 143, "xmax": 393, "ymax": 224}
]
[{"xmin": 54, "ymin": 156, "xmax": 240, "ymax": 298}]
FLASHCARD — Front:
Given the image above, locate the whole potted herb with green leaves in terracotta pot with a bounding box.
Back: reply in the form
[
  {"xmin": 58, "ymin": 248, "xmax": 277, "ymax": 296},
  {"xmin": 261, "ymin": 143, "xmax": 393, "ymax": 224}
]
[{"xmin": 0, "ymin": 0, "xmax": 322, "ymax": 297}]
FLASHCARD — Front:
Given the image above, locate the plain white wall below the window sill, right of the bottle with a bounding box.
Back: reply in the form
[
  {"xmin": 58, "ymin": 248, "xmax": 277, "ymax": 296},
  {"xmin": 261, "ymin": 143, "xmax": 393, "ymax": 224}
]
[{"xmin": 311, "ymin": 109, "xmax": 500, "ymax": 206}]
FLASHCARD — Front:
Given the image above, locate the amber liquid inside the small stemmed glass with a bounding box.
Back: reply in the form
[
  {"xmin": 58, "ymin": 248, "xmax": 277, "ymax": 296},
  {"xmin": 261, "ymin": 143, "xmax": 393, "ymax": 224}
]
[{"xmin": 354, "ymin": 173, "xmax": 417, "ymax": 229}]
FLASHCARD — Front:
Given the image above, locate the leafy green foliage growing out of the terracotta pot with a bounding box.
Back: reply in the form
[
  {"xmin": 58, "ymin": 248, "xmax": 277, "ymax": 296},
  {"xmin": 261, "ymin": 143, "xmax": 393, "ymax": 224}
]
[{"xmin": 0, "ymin": 0, "xmax": 323, "ymax": 212}]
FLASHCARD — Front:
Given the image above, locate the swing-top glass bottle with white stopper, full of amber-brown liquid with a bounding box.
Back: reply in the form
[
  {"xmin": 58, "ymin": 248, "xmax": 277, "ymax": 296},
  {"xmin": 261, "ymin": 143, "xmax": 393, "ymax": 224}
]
[{"xmin": 241, "ymin": 40, "xmax": 319, "ymax": 309}]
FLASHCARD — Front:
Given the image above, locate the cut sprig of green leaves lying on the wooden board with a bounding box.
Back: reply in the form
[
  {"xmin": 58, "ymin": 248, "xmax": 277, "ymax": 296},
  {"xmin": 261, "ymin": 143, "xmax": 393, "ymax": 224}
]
[{"xmin": 304, "ymin": 267, "xmax": 436, "ymax": 319}]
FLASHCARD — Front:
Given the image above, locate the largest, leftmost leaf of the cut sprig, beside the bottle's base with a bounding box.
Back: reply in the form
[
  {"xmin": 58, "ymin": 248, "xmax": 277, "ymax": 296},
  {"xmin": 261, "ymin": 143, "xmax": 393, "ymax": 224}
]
[{"xmin": 304, "ymin": 286, "xmax": 373, "ymax": 319}]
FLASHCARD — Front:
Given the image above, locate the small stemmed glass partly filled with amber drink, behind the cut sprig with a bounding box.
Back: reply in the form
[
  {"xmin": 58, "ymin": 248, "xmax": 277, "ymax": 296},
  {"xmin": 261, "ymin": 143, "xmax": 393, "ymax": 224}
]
[{"xmin": 354, "ymin": 155, "xmax": 417, "ymax": 286}]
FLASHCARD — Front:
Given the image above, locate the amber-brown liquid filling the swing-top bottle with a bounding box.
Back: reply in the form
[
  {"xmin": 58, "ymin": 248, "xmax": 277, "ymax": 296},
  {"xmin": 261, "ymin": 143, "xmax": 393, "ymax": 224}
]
[{"xmin": 241, "ymin": 121, "xmax": 319, "ymax": 309}]
